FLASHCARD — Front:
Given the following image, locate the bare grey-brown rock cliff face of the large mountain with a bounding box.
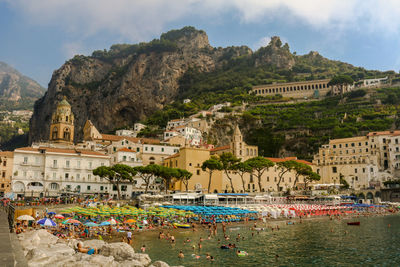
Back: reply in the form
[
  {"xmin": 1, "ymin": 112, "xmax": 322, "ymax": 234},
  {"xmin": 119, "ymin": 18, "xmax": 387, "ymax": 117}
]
[{"xmin": 29, "ymin": 27, "xmax": 293, "ymax": 142}]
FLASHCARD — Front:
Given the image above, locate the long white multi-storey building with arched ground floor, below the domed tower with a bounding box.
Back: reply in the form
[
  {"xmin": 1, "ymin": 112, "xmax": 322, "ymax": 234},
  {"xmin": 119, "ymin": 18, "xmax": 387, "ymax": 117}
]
[{"xmin": 12, "ymin": 147, "xmax": 110, "ymax": 197}]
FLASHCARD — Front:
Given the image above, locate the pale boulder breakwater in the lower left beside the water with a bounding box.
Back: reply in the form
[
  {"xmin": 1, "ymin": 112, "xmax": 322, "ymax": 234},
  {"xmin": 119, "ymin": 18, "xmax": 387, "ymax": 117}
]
[{"xmin": 18, "ymin": 229, "xmax": 181, "ymax": 267}]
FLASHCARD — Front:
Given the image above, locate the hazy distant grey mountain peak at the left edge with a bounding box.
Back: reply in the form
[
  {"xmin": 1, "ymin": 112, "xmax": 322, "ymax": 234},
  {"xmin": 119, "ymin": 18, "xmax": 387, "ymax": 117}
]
[{"xmin": 0, "ymin": 61, "xmax": 46, "ymax": 110}]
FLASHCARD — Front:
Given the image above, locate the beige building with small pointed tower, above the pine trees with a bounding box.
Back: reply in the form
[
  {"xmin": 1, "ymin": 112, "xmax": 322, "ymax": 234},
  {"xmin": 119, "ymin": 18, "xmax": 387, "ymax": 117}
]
[{"xmin": 211, "ymin": 125, "xmax": 258, "ymax": 161}]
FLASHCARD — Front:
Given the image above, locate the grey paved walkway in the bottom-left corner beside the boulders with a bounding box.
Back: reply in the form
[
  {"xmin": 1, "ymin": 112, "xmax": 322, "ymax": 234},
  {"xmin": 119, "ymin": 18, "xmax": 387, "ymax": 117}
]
[{"xmin": 0, "ymin": 210, "xmax": 28, "ymax": 267}]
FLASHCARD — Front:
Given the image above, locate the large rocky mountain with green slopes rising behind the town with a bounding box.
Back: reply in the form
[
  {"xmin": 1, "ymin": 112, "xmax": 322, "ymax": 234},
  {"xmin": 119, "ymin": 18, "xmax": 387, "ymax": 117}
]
[{"xmin": 29, "ymin": 27, "xmax": 394, "ymax": 151}]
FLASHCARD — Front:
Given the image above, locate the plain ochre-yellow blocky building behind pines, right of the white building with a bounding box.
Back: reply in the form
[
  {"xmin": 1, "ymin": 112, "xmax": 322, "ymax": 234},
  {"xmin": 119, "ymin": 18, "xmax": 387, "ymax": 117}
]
[{"xmin": 164, "ymin": 147, "xmax": 222, "ymax": 192}]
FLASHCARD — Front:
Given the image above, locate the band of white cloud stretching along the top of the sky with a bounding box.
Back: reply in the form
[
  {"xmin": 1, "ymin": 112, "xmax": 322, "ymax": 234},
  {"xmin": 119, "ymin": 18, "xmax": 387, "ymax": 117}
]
[{"xmin": 0, "ymin": 0, "xmax": 400, "ymax": 42}]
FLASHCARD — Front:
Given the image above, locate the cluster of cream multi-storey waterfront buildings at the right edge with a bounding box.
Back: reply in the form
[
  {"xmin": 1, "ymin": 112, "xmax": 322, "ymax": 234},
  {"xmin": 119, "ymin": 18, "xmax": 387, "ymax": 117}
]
[{"xmin": 313, "ymin": 131, "xmax": 400, "ymax": 189}]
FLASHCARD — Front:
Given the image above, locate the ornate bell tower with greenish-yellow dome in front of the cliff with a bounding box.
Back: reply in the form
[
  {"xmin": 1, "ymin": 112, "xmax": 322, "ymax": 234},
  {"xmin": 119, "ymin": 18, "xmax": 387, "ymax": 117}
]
[{"xmin": 49, "ymin": 97, "xmax": 75, "ymax": 144}]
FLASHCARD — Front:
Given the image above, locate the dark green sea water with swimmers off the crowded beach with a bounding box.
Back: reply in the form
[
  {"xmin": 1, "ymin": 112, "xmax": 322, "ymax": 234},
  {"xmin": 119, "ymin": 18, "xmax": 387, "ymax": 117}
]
[{"xmin": 133, "ymin": 215, "xmax": 400, "ymax": 267}]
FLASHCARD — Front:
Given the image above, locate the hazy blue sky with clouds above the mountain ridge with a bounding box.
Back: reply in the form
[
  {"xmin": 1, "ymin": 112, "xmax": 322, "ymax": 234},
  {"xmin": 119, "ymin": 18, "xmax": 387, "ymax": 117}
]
[{"xmin": 0, "ymin": 0, "xmax": 400, "ymax": 88}]
